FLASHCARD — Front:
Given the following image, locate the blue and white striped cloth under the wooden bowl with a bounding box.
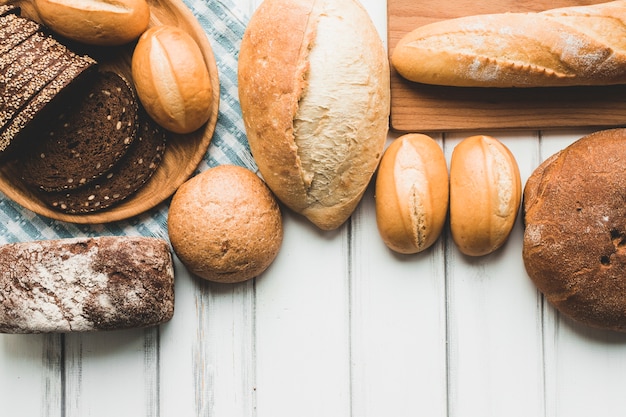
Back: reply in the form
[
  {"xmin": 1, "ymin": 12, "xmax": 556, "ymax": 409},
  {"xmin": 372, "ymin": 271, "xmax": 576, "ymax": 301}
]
[{"xmin": 0, "ymin": 0, "xmax": 257, "ymax": 244}]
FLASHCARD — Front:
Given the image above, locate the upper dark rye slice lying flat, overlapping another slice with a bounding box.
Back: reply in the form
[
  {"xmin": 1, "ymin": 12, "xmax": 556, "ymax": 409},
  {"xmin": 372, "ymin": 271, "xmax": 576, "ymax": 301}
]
[{"xmin": 21, "ymin": 71, "xmax": 138, "ymax": 191}]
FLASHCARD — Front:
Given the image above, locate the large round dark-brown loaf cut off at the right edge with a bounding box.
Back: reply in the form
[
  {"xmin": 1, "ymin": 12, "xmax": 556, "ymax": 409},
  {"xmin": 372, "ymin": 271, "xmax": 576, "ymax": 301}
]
[{"xmin": 522, "ymin": 129, "xmax": 626, "ymax": 332}]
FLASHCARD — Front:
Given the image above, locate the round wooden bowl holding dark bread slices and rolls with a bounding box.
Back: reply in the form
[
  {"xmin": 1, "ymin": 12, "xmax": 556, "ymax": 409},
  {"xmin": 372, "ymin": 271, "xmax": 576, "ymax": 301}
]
[{"xmin": 0, "ymin": 0, "xmax": 220, "ymax": 224}]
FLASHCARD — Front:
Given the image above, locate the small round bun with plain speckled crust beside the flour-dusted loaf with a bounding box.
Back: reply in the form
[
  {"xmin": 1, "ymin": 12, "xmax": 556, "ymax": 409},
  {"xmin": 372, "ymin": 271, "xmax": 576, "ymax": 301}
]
[{"xmin": 167, "ymin": 165, "xmax": 283, "ymax": 283}]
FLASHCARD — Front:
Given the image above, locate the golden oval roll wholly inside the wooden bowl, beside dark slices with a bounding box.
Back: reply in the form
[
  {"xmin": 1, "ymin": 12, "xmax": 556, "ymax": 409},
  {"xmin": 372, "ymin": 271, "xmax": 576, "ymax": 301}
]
[{"xmin": 131, "ymin": 25, "xmax": 213, "ymax": 134}]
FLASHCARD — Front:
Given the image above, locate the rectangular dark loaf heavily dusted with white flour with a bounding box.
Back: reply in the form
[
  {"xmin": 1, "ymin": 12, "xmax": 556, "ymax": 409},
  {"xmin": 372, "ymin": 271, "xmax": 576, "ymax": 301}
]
[{"xmin": 0, "ymin": 236, "xmax": 174, "ymax": 333}]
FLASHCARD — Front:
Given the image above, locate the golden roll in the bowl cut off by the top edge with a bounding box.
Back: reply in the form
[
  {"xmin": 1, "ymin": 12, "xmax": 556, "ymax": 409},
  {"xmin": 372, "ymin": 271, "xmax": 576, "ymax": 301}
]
[{"xmin": 35, "ymin": 0, "xmax": 150, "ymax": 46}]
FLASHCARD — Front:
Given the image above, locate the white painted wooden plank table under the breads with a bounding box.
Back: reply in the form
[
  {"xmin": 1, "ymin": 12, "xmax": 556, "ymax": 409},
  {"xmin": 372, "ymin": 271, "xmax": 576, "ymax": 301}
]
[{"xmin": 0, "ymin": 0, "xmax": 626, "ymax": 417}]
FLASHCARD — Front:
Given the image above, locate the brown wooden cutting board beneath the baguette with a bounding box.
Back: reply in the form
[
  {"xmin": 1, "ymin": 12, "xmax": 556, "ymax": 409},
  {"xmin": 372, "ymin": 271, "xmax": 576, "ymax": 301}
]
[{"xmin": 387, "ymin": 0, "xmax": 626, "ymax": 132}]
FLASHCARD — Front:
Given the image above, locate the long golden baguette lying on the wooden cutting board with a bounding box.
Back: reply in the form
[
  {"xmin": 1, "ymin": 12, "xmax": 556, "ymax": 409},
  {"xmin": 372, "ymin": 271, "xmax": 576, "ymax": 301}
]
[{"xmin": 392, "ymin": 0, "xmax": 626, "ymax": 87}]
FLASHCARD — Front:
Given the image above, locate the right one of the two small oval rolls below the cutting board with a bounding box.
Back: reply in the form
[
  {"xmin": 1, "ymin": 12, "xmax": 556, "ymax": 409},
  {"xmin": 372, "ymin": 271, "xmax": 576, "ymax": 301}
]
[{"xmin": 450, "ymin": 136, "xmax": 522, "ymax": 256}]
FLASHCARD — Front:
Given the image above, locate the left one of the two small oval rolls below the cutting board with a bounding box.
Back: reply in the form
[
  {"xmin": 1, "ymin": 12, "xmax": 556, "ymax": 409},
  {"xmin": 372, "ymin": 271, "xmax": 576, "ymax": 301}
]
[{"xmin": 376, "ymin": 134, "xmax": 448, "ymax": 254}]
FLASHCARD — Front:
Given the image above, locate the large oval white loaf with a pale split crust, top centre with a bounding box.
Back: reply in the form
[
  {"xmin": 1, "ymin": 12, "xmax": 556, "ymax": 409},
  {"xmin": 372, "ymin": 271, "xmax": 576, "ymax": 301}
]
[{"xmin": 239, "ymin": 0, "xmax": 390, "ymax": 230}]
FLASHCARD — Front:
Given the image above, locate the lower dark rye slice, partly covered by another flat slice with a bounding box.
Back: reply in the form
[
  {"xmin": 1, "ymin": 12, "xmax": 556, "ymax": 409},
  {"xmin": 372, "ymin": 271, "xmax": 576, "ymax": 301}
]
[{"xmin": 39, "ymin": 110, "xmax": 168, "ymax": 214}]
